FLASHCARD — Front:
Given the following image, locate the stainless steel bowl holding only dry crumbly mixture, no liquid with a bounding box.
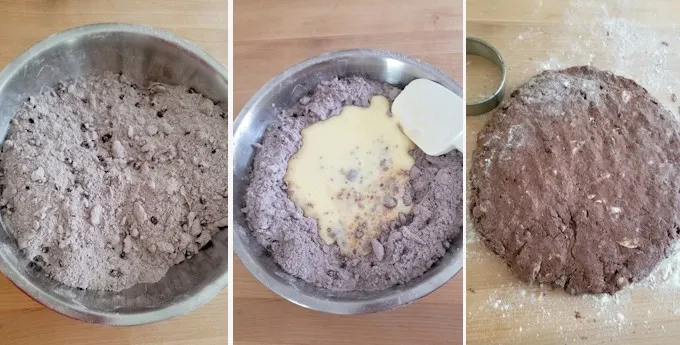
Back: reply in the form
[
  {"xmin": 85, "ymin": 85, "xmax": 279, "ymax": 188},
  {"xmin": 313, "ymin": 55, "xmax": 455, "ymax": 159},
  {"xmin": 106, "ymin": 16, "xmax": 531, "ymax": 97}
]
[{"xmin": 0, "ymin": 24, "xmax": 228, "ymax": 327}]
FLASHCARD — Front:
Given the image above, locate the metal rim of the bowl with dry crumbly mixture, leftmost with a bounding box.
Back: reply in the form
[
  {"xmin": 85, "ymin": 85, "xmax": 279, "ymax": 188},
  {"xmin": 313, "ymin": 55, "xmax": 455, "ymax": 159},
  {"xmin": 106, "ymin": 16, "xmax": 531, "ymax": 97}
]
[{"xmin": 0, "ymin": 23, "xmax": 229, "ymax": 326}]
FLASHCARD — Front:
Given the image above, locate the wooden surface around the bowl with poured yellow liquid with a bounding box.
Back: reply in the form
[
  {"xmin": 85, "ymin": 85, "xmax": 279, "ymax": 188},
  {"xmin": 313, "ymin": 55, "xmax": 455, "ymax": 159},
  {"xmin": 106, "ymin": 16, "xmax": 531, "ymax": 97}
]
[{"xmin": 233, "ymin": 0, "xmax": 463, "ymax": 345}]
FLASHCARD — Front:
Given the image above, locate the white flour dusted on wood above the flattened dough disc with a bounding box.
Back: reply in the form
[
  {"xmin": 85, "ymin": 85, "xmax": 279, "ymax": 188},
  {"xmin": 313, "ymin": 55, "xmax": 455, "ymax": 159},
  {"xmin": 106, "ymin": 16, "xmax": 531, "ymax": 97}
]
[{"xmin": 509, "ymin": 0, "xmax": 680, "ymax": 116}]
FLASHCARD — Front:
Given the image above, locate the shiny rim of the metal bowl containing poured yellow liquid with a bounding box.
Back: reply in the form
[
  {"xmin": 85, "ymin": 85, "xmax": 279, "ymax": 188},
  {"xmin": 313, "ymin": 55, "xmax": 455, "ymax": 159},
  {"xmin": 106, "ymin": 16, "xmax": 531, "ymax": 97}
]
[{"xmin": 232, "ymin": 49, "xmax": 465, "ymax": 315}]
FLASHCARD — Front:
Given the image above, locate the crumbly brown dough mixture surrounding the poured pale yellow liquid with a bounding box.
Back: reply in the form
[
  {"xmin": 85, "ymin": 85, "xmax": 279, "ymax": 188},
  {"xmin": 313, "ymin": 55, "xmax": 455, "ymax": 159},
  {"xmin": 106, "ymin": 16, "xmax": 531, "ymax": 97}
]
[{"xmin": 243, "ymin": 77, "xmax": 463, "ymax": 291}]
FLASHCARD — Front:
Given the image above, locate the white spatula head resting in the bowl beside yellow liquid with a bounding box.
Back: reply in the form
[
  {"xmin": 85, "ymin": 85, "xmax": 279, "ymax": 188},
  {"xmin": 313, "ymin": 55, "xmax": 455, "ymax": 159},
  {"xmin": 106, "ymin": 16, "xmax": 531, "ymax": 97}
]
[{"xmin": 392, "ymin": 79, "xmax": 465, "ymax": 156}]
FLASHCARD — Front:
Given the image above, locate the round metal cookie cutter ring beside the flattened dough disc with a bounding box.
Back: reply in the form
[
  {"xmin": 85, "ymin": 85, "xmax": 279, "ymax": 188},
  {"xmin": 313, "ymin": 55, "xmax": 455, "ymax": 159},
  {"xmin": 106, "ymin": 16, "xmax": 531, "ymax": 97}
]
[{"xmin": 465, "ymin": 37, "xmax": 505, "ymax": 116}]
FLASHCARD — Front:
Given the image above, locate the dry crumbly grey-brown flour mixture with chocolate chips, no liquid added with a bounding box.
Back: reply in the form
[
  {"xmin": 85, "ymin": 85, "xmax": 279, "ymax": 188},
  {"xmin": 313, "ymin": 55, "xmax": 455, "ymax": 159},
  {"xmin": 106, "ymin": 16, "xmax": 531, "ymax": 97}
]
[{"xmin": 0, "ymin": 73, "xmax": 227, "ymax": 291}]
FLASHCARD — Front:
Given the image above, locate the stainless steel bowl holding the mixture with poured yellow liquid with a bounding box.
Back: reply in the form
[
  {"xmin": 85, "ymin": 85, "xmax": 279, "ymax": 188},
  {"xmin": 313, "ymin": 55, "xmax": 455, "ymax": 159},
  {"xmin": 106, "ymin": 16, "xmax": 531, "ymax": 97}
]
[{"xmin": 232, "ymin": 50, "xmax": 463, "ymax": 314}]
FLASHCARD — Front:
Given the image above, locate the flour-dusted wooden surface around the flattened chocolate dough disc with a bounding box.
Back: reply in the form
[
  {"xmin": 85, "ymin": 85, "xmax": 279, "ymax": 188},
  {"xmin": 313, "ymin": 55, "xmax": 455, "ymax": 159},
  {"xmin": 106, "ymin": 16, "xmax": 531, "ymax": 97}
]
[{"xmin": 466, "ymin": 0, "xmax": 680, "ymax": 344}]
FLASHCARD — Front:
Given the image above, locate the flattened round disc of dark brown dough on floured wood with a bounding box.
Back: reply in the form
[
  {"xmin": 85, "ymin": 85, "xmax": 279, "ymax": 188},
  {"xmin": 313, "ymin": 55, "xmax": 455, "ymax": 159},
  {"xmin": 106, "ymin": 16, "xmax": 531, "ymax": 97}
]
[{"xmin": 470, "ymin": 67, "xmax": 680, "ymax": 294}]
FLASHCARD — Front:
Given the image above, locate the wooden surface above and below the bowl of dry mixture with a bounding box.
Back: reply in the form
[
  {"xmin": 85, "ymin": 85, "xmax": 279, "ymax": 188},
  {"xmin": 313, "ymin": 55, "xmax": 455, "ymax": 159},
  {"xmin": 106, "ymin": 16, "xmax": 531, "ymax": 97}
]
[{"xmin": 0, "ymin": 0, "xmax": 228, "ymax": 345}]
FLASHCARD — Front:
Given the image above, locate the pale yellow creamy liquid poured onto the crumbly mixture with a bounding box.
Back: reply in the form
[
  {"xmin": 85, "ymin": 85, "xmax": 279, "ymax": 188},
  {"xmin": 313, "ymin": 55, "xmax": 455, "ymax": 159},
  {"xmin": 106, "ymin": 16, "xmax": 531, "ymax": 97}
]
[{"xmin": 284, "ymin": 96, "xmax": 415, "ymax": 257}]
